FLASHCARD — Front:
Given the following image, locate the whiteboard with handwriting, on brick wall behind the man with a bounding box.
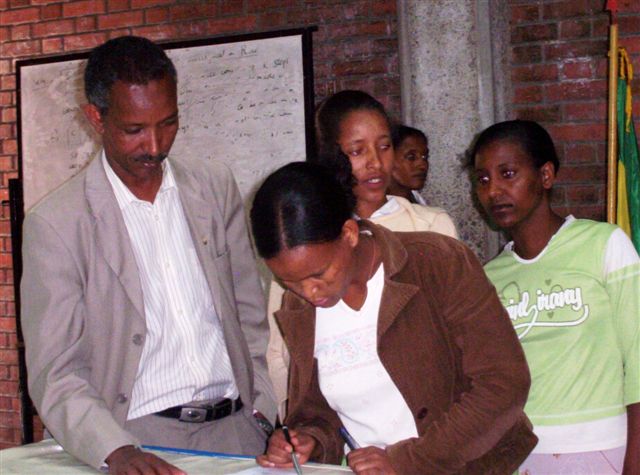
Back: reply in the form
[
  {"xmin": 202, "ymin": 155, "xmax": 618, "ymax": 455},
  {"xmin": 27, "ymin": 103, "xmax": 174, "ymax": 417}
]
[{"xmin": 16, "ymin": 29, "xmax": 313, "ymax": 209}]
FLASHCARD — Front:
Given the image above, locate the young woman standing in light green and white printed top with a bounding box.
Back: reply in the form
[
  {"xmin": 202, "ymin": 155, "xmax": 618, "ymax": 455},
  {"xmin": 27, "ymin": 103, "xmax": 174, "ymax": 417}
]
[{"xmin": 472, "ymin": 120, "xmax": 640, "ymax": 475}]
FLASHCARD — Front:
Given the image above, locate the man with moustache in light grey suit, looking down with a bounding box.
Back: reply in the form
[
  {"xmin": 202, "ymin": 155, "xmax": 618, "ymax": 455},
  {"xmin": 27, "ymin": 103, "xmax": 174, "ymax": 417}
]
[{"xmin": 21, "ymin": 36, "xmax": 275, "ymax": 474}]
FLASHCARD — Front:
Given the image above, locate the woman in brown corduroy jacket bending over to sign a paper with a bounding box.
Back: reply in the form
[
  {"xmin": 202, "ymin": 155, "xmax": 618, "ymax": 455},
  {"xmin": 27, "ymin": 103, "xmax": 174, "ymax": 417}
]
[{"xmin": 251, "ymin": 163, "xmax": 536, "ymax": 474}]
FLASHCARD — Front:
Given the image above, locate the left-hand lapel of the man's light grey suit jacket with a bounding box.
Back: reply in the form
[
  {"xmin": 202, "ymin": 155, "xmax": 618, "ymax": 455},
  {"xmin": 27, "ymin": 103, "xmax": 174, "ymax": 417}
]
[{"xmin": 85, "ymin": 159, "xmax": 144, "ymax": 319}]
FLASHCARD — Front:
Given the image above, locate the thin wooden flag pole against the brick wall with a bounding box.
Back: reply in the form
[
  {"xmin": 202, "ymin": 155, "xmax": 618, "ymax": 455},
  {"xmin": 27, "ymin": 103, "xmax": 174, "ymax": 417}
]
[{"xmin": 607, "ymin": 2, "xmax": 618, "ymax": 223}]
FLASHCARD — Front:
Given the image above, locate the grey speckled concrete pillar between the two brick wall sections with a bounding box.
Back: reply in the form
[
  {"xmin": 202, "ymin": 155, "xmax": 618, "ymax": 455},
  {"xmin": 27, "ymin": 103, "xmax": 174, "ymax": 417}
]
[{"xmin": 398, "ymin": 0, "xmax": 508, "ymax": 261}]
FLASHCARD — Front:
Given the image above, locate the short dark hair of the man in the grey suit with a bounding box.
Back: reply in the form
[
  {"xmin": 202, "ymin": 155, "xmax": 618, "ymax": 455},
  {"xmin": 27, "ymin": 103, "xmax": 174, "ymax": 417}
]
[{"xmin": 84, "ymin": 36, "xmax": 178, "ymax": 114}]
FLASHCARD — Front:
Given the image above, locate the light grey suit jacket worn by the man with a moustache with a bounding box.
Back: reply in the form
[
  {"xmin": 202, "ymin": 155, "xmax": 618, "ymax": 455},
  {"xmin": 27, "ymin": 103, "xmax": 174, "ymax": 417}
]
[{"xmin": 21, "ymin": 155, "xmax": 275, "ymax": 467}]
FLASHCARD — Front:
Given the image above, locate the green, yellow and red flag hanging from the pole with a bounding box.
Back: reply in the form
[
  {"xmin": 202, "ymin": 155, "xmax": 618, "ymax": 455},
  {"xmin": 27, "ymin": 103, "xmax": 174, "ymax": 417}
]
[{"xmin": 616, "ymin": 48, "xmax": 640, "ymax": 252}]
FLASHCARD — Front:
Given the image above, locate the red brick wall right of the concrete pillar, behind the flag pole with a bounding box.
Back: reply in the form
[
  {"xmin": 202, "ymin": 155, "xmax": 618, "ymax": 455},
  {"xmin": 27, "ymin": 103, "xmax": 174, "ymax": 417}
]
[{"xmin": 509, "ymin": 0, "xmax": 640, "ymax": 220}]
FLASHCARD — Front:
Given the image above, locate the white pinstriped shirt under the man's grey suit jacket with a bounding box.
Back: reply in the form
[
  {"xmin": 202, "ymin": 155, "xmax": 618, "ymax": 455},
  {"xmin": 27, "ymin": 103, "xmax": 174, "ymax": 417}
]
[{"xmin": 102, "ymin": 151, "xmax": 238, "ymax": 419}]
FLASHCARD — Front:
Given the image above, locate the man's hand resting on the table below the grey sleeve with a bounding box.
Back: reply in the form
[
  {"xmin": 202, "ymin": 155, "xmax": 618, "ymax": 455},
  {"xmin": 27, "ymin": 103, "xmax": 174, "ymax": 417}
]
[{"xmin": 105, "ymin": 445, "xmax": 187, "ymax": 475}]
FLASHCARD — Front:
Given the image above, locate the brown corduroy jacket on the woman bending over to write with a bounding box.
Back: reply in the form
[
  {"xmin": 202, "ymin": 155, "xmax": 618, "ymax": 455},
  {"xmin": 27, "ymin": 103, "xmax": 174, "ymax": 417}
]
[{"xmin": 276, "ymin": 221, "xmax": 537, "ymax": 474}]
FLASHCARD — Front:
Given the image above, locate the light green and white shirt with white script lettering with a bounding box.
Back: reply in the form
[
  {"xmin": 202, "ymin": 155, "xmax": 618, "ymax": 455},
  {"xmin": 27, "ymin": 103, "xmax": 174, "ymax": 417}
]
[{"xmin": 485, "ymin": 216, "xmax": 640, "ymax": 453}]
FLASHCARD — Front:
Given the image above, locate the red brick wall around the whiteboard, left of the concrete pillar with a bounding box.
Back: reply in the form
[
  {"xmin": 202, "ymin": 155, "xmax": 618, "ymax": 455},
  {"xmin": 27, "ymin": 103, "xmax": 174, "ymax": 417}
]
[{"xmin": 0, "ymin": 0, "xmax": 400, "ymax": 448}]
